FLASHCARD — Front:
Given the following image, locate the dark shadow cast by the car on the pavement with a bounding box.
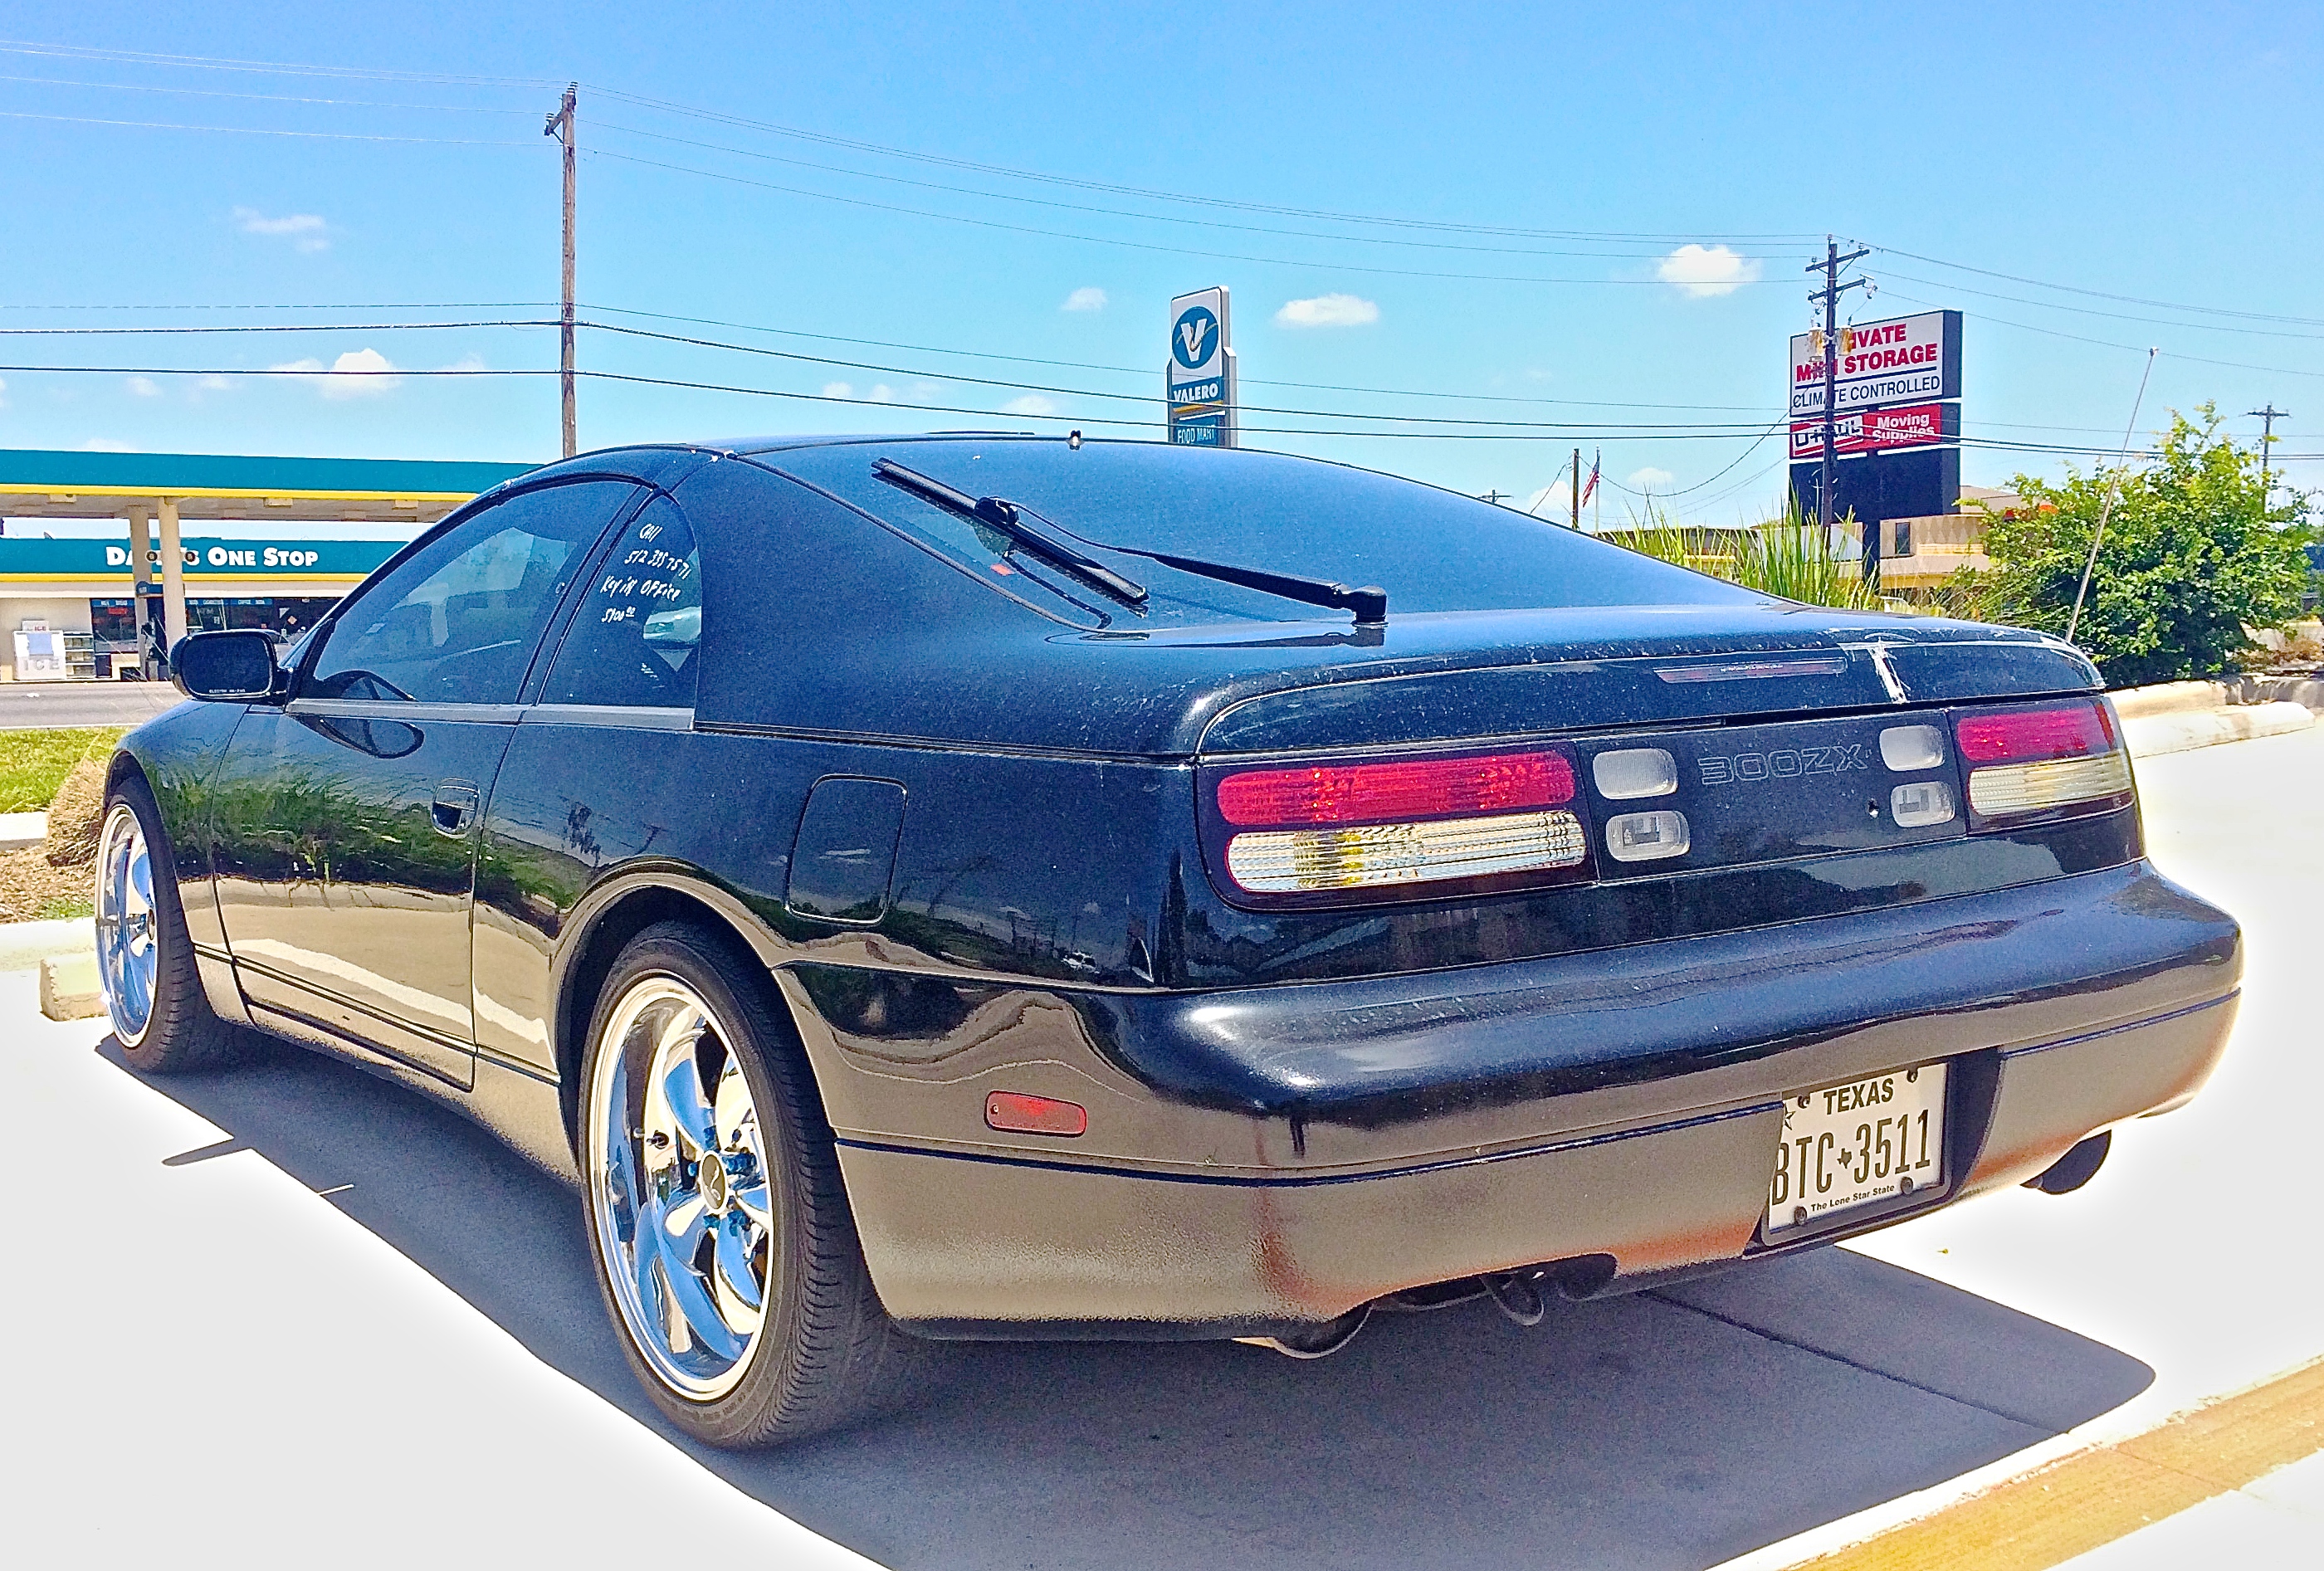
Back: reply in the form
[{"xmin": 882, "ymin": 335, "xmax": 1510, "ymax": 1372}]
[{"xmin": 100, "ymin": 1039, "xmax": 2152, "ymax": 1571}]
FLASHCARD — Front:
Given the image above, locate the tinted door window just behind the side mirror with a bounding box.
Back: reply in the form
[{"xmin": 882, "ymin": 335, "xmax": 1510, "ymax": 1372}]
[{"xmin": 307, "ymin": 481, "xmax": 637, "ymax": 704}]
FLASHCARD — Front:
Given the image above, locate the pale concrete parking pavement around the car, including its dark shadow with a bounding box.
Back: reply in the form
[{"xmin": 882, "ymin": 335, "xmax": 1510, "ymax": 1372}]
[{"xmin": 0, "ymin": 732, "xmax": 2324, "ymax": 1571}]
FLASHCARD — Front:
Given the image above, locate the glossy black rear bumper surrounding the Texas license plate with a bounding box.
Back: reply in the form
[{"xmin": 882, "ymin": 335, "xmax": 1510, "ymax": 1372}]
[{"xmin": 808, "ymin": 862, "xmax": 2240, "ymax": 1336}]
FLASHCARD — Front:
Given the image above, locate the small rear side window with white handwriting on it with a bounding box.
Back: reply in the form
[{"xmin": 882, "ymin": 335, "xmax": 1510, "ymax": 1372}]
[{"xmin": 540, "ymin": 497, "xmax": 702, "ymax": 709}]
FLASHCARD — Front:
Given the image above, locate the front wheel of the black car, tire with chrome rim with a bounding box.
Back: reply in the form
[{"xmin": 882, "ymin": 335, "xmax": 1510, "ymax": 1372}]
[{"xmin": 95, "ymin": 773, "xmax": 242, "ymax": 1074}]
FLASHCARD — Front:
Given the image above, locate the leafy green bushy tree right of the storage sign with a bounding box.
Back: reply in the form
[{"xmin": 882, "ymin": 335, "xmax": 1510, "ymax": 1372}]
[{"xmin": 1982, "ymin": 404, "xmax": 2310, "ymax": 688}]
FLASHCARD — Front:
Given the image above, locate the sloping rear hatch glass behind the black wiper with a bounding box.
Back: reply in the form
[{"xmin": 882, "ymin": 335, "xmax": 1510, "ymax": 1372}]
[{"xmin": 760, "ymin": 439, "xmax": 1760, "ymax": 621}]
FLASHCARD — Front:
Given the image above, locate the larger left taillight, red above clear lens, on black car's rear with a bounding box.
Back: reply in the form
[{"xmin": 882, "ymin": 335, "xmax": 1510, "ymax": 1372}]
[{"xmin": 1211, "ymin": 749, "xmax": 1589, "ymax": 904}]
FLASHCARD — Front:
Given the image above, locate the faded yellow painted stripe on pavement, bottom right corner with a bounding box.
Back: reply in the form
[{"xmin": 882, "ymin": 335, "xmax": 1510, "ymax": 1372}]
[{"xmin": 1801, "ymin": 1359, "xmax": 2324, "ymax": 1571}]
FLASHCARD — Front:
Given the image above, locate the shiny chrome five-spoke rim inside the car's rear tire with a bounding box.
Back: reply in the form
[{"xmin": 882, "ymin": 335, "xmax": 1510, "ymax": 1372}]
[{"xmin": 588, "ymin": 976, "xmax": 776, "ymax": 1402}]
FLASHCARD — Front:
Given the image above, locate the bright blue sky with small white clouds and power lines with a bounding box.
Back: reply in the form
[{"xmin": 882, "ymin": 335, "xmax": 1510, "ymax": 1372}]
[{"xmin": 0, "ymin": 0, "xmax": 2324, "ymax": 534}]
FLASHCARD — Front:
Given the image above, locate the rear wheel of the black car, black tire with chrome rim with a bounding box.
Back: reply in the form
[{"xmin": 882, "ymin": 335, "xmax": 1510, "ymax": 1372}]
[{"xmin": 581, "ymin": 923, "xmax": 918, "ymax": 1448}]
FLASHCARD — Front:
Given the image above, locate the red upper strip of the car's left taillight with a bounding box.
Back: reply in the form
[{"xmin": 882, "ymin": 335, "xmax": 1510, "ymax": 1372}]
[{"xmin": 1218, "ymin": 753, "xmax": 1574, "ymax": 825}]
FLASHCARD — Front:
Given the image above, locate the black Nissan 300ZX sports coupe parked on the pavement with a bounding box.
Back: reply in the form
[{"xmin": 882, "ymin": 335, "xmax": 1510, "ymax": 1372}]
[{"xmin": 98, "ymin": 435, "xmax": 2240, "ymax": 1446}]
